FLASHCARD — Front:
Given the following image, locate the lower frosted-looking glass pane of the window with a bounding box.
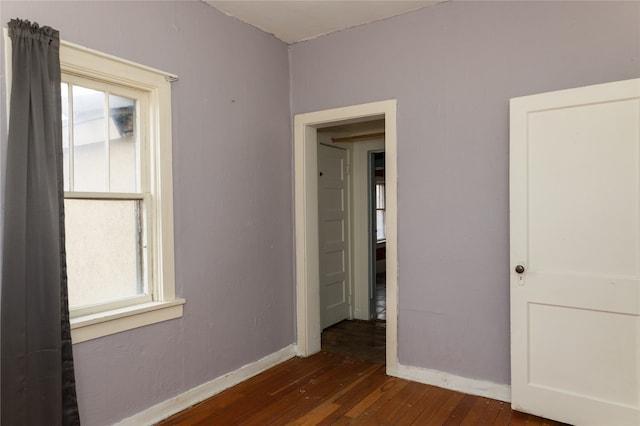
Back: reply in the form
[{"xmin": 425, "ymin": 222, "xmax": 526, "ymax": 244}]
[{"xmin": 64, "ymin": 199, "xmax": 146, "ymax": 309}]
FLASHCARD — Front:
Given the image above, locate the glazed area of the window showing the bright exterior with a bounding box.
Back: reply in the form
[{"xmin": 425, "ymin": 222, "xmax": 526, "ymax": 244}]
[{"xmin": 61, "ymin": 77, "xmax": 150, "ymax": 310}]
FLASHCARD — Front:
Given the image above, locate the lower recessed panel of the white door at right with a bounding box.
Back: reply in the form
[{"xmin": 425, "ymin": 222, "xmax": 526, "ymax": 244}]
[{"xmin": 529, "ymin": 303, "xmax": 638, "ymax": 405}]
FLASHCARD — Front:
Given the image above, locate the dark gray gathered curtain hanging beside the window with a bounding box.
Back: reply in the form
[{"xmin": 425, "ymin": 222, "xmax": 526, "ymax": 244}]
[{"xmin": 0, "ymin": 20, "xmax": 80, "ymax": 426}]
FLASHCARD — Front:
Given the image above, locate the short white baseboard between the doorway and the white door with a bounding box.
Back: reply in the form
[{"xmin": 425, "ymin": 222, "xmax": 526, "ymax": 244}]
[{"xmin": 391, "ymin": 364, "xmax": 511, "ymax": 402}]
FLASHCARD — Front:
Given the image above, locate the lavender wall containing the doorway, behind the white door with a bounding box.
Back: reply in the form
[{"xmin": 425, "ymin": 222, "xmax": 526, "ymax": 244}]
[{"xmin": 290, "ymin": 1, "xmax": 640, "ymax": 383}]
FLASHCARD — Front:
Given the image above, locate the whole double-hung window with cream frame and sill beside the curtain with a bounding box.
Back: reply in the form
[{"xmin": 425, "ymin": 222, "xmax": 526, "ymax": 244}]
[{"xmin": 60, "ymin": 43, "xmax": 184, "ymax": 342}]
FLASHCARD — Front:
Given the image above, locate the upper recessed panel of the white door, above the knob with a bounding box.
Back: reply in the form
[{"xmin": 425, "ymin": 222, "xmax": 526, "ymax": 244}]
[{"xmin": 529, "ymin": 100, "xmax": 640, "ymax": 275}]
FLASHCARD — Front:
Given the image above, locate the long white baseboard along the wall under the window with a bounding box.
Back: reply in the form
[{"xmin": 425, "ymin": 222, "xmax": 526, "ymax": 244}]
[{"xmin": 116, "ymin": 344, "xmax": 296, "ymax": 426}]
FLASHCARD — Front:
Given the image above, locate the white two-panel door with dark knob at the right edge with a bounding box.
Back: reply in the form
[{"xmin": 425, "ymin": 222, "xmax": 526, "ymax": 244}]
[{"xmin": 510, "ymin": 80, "xmax": 640, "ymax": 425}]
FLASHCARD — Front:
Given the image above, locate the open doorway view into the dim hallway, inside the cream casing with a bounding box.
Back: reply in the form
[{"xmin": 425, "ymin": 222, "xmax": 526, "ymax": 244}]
[{"xmin": 317, "ymin": 119, "xmax": 387, "ymax": 364}]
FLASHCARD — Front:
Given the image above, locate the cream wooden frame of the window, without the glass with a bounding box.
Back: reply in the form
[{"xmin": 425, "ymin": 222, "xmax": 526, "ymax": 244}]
[{"xmin": 60, "ymin": 41, "xmax": 185, "ymax": 343}]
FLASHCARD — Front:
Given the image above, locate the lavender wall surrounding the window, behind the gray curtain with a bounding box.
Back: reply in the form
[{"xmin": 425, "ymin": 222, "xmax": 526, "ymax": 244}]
[{"xmin": 0, "ymin": 0, "xmax": 295, "ymax": 425}]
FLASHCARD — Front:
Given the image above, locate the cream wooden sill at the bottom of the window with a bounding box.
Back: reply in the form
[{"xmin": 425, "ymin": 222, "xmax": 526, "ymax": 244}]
[{"xmin": 70, "ymin": 299, "xmax": 185, "ymax": 343}]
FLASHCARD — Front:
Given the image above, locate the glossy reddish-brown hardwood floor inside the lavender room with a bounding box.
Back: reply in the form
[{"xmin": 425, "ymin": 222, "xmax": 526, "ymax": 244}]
[{"xmin": 159, "ymin": 351, "xmax": 561, "ymax": 426}]
